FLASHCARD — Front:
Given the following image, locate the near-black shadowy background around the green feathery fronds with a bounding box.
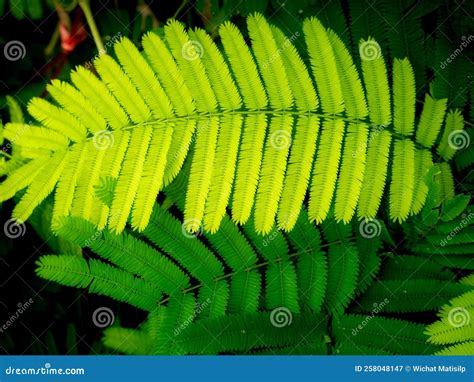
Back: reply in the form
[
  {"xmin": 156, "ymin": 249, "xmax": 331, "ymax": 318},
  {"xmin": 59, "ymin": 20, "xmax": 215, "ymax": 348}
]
[{"xmin": 0, "ymin": 0, "xmax": 474, "ymax": 354}]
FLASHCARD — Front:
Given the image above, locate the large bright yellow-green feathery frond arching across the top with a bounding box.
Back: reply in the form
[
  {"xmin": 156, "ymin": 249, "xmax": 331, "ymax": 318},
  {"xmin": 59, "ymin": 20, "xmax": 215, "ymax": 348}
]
[{"xmin": 0, "ymin": 15, "xmax": 463, "ymax": 233}]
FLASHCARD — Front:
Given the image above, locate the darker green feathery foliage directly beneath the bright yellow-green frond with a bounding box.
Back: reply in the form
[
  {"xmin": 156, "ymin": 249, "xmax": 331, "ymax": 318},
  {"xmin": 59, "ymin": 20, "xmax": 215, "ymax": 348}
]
[{"xmin": 30, "ymin": 161, "xmax": 472, "ymax": 354}]
